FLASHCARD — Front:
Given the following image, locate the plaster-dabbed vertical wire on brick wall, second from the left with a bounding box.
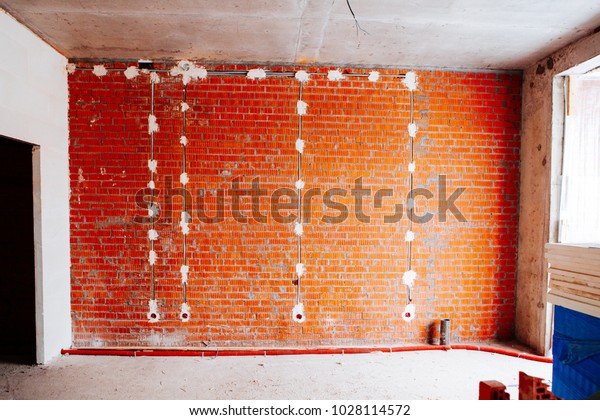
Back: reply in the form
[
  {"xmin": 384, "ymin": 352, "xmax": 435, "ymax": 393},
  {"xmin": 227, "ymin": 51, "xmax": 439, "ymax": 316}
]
[{"xmin": 179, "ymin": 84, "xmax": 190, "ymax": 322}]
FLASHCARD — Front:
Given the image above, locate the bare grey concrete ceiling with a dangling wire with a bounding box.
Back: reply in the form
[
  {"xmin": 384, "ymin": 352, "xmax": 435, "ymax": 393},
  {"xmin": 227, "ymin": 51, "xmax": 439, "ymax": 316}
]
[{"xmin": 0, "ymin": 0, "xmax": 600, "ymax": 69}]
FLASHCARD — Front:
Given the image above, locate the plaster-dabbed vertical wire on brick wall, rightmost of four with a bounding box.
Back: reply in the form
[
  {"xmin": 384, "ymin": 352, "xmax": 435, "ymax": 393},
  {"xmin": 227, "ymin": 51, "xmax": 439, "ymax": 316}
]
[{"xmin": 402, "ymin": 72, "xmax": 417, "ymax": 321}]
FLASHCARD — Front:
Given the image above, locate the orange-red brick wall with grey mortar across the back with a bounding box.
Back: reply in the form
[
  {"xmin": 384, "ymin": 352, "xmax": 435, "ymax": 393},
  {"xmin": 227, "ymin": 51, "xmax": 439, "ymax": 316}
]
[{"xmin": 69, "ymin": 63, "xmax": 521, "ymax": 347}]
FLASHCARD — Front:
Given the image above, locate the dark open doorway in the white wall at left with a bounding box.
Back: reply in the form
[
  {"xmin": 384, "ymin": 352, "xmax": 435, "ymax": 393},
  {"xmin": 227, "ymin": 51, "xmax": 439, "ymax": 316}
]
[{"xmin": 0, "ymin": 136, "xmax": 36, "ymax": 364}]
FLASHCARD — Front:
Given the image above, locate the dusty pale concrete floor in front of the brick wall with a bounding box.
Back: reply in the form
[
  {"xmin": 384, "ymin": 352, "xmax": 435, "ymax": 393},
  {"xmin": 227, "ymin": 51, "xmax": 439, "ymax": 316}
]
[{"xmin": 0, "ymin": 350, "xmax": 552, "ymax": 400}]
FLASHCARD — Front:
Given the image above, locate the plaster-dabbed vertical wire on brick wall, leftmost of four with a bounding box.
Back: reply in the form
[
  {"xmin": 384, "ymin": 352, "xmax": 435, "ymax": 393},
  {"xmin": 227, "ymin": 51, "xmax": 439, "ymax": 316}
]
[{"xmin": 147, "ymin": 77, "xmax": 160, "ymax": 323}]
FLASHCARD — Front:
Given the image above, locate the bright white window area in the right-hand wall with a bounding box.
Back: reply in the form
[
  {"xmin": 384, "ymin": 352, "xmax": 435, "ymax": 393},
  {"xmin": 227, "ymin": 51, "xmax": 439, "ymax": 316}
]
[{"xmin": 559, "ymin": 77, "xmax": 600, "ymax": 244}]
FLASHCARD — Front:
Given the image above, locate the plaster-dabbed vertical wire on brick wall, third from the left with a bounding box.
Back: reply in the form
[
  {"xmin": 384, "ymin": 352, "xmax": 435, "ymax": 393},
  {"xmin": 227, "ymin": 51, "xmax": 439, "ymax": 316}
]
[{"xmin": 292, "ymin": 70, "xmax": 308, "ymax": 323}]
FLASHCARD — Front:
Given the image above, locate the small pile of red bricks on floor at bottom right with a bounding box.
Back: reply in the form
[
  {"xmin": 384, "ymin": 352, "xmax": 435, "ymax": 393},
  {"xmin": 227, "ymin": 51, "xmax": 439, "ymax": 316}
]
[{"xmin": 479, "ymin": 372, "xmax": 561, "ymax": 400}]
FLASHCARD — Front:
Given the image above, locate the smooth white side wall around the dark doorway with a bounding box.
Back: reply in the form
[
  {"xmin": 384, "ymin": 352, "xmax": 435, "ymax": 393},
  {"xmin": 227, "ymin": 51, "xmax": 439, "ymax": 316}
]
[{"xmin": 0, "ymin": 10, "xmax": 72, "ymax": 363}]
